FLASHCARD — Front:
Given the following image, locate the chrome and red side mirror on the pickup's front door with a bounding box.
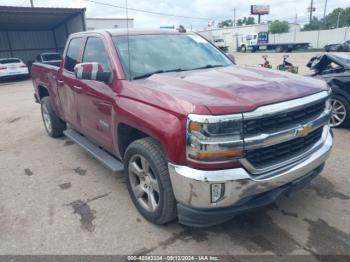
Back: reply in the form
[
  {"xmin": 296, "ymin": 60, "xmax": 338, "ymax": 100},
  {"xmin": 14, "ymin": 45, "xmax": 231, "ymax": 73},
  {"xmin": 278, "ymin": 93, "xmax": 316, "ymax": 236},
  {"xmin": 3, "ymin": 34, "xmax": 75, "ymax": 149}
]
[{"xmin": 74, "ymin": 63, "xmax": 112, "ymax": 83}]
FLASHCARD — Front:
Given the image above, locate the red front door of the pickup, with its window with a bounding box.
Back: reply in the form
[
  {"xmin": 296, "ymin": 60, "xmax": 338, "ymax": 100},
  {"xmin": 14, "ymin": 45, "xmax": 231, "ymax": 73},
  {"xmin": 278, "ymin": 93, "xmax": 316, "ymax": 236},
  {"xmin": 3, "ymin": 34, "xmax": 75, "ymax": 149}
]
[{"xmin": 76, "ymin": 36, "xmax": 115, "ymax": 152}]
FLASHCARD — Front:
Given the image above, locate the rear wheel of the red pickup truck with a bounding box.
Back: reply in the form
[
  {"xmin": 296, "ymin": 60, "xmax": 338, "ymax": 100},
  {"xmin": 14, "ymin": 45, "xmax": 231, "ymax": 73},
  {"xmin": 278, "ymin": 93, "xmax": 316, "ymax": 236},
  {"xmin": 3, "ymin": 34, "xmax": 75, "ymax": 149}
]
[{"xmin": 41, "ymin": 96, "xmax": 67, "ymax": 137}]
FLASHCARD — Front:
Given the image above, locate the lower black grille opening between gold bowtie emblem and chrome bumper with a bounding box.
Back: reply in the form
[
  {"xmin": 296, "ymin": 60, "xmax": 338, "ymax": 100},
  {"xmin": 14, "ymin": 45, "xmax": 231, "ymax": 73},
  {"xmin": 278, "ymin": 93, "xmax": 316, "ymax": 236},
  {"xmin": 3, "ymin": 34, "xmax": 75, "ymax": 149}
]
[{"xmin": 246, "ymin": 127, "xmax": 323, "ymax": 169}]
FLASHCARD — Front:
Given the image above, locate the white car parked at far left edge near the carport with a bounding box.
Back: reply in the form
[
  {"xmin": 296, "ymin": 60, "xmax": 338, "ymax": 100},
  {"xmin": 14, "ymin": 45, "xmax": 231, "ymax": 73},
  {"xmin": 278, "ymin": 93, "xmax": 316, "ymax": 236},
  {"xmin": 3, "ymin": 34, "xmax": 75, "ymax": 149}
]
[{"xmin": 0, "ymin": 58, "xmax": 29, "ymax": 80}]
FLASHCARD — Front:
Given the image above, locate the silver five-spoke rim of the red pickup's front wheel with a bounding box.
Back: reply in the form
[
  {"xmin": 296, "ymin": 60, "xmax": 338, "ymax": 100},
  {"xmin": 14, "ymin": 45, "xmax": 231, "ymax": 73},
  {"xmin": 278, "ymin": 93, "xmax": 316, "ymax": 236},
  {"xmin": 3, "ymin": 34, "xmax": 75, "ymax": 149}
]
[{"xmin": 128, "ymin": 155, "xmax": 160, "ymax": 212}]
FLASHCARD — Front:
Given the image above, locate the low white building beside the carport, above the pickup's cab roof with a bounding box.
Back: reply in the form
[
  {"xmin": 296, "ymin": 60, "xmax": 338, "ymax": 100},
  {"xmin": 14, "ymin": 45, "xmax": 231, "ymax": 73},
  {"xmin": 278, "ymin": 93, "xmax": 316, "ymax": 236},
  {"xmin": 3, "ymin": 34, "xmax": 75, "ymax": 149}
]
[{"xmin": 86, "ymin": 18, "xmax": 134, "ymax": 30}]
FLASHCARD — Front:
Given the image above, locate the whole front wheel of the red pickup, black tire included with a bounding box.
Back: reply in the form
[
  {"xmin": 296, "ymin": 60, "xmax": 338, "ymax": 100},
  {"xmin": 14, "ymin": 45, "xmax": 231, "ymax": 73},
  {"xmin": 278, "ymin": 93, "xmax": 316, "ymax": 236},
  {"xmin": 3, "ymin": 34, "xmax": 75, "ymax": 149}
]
[{"xmin": 124, "ymin": 137, "xmax": 177, "ymax": 225}]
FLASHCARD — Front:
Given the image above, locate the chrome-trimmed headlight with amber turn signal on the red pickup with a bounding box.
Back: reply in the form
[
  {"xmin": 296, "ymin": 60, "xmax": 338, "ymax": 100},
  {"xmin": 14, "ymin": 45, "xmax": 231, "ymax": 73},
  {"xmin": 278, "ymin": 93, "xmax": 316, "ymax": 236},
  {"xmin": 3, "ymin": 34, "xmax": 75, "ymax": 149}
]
[{"xmin": 186, "ymin": 114, "xmax": 243, "ymax": 162}]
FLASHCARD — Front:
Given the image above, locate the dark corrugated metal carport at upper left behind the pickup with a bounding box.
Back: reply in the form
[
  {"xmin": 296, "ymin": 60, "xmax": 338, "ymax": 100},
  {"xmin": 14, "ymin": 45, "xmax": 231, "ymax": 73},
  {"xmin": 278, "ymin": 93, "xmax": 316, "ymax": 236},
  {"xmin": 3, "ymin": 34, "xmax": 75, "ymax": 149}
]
[{"xmin": 0, "ymin": 6, "xmax": 86, "ymax": 64}]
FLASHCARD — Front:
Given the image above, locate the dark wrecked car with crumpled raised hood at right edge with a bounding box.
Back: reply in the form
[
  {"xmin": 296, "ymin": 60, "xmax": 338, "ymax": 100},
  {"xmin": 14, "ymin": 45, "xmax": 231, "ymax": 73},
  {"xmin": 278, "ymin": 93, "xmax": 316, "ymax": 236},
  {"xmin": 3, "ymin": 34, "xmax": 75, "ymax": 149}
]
[{"xmin": 307, "ymin": 54, "xmax": 350, "ymax": 127}]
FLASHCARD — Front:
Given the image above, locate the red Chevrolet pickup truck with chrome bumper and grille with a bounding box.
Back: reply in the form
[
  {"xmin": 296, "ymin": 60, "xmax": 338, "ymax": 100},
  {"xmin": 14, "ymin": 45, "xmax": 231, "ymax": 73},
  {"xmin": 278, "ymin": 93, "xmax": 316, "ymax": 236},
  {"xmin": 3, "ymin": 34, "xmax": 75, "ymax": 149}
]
[{"xmin": 32, "ymin": 30, "xmax": 332, "ymax": 227}]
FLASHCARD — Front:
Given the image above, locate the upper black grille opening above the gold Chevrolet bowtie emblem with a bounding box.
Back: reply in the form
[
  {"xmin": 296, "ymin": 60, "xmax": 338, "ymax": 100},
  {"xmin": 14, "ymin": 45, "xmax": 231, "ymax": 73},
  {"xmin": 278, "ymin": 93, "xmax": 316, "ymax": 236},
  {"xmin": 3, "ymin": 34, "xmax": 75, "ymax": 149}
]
[{"xmin": 243, "ymin": 100, "xmax": 325, "ymax": 135}]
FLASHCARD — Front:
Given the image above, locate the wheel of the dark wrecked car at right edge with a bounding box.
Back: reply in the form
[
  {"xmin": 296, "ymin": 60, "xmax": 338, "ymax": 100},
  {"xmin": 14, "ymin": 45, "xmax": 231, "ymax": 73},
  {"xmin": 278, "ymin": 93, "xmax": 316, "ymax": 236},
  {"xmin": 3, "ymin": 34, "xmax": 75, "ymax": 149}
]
[{"xmin": 330, "ymin": 95, "xmax": 350, "ymax": 128}]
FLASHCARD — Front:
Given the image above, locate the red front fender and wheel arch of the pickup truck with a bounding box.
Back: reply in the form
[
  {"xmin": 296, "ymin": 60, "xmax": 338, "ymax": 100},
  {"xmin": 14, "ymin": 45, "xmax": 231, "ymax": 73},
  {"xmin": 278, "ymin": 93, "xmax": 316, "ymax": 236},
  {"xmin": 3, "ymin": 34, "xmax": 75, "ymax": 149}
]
[{"xmin": 114, "ymin": 98, "xmax": 186, "ymax": 163}]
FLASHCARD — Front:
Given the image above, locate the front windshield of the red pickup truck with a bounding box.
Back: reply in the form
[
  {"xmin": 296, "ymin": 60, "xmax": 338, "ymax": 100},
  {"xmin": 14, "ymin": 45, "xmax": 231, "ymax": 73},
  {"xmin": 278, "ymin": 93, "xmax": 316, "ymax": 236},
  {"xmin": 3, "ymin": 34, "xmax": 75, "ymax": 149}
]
[{"xmin": 113, "ymin": 34, "xmax": 232, "ymax": 79}]
